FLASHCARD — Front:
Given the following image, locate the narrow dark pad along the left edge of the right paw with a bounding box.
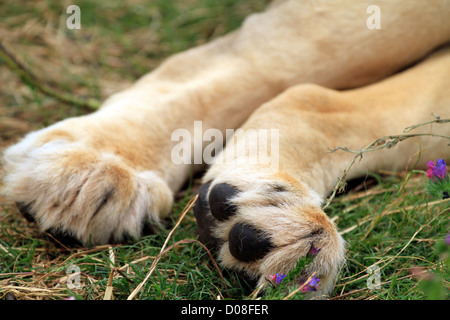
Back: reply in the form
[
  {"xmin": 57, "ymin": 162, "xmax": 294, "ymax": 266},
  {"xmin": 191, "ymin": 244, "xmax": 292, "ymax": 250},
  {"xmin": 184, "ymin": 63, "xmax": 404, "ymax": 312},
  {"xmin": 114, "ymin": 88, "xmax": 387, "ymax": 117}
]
[{"xmin": 194, "ymin": 183, "xmax": 218, "ymax": 248}]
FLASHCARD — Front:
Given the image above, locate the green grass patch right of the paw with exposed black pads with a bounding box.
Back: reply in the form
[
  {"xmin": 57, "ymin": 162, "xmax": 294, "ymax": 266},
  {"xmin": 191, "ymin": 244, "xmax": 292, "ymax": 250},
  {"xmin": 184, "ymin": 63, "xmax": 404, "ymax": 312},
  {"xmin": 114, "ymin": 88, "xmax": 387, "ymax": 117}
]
[{"xmin": 328, "ymin": 173, "xmax": 450, "ymax": 300}]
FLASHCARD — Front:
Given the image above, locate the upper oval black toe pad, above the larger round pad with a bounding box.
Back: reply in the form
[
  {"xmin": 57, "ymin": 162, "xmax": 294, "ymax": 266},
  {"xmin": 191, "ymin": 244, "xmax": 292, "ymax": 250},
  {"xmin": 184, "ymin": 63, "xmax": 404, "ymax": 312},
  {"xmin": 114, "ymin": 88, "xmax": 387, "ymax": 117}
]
[{"xmin": 209, "ymin": 183, "xmax": 238, "ymax": 221}]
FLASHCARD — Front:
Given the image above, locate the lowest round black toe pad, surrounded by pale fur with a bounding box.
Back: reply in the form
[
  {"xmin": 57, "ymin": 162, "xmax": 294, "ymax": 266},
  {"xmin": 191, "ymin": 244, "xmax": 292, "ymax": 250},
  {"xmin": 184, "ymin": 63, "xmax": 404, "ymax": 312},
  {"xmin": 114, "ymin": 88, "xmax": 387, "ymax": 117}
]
[{"xmin": 228, "ymin": 223, "xmax": 272, "ymax": 262}]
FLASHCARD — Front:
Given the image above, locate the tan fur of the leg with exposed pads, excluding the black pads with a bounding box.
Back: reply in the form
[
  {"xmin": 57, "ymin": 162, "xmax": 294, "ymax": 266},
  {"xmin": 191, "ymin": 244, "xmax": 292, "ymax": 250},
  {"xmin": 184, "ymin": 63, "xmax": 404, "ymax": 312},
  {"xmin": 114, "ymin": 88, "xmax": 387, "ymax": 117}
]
[{"xmin": 204, "ymin": 47, "xmax": 450, "ymax": 293}]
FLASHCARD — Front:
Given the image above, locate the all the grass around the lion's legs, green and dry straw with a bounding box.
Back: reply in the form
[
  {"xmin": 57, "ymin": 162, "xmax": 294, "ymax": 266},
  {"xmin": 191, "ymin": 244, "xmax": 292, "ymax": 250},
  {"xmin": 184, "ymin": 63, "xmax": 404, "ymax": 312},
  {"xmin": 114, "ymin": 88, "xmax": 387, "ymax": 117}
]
[{"xmin": 0, "ymin": 0, "xmax": 450, "ymax": 300}]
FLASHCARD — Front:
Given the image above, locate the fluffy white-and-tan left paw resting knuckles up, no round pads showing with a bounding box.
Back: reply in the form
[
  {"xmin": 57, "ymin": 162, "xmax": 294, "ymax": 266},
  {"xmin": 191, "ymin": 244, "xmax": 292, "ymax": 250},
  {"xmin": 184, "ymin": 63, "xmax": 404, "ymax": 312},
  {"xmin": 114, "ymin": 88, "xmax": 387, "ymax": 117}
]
[{"xmin": 3, "ymin": 125, "xmax": 172, "ymax": 244}]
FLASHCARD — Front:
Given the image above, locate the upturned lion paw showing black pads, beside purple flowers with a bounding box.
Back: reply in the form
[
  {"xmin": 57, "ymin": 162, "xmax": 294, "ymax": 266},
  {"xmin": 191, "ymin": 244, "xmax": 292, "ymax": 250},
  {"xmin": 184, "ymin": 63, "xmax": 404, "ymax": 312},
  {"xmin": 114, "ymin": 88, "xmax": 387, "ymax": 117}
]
[{"xmin": 194, "ymin": 172, "xmax": 345, "ymax": 295}]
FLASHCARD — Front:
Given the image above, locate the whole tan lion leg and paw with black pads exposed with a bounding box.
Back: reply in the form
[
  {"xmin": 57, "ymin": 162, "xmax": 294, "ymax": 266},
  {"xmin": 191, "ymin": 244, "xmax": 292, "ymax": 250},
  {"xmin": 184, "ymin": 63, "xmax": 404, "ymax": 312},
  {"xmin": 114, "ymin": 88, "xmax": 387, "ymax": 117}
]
[{"xmin": 195, "ymin": 47, "xmax": 450, "ymax": 295}]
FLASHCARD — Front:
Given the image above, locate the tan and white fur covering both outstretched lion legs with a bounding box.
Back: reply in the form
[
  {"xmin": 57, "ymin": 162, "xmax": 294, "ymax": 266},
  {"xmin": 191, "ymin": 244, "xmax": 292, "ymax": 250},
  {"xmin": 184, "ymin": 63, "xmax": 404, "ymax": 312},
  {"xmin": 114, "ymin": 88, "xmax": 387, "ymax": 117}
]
[{"xmin": 3, "ymin": 0, "xmax": 450, "ymax": 294}]
